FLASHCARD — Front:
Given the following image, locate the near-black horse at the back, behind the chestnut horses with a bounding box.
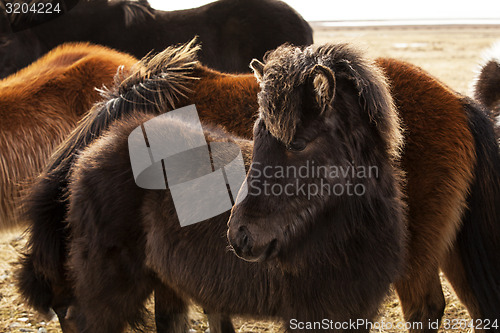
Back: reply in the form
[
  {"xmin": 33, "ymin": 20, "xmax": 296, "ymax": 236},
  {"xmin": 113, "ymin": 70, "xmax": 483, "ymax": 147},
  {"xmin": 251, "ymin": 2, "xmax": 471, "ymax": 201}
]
[{"xmin": 0, "ymin": 0, "xmax": 313, "ymax": 77}]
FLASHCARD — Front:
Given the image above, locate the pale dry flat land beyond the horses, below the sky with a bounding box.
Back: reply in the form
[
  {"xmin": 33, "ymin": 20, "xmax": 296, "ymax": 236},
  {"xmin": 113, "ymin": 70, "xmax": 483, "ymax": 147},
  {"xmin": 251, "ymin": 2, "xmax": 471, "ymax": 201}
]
[{"xmin": 313, "ymin": 25, "xmax": 500, "ymax": 94}]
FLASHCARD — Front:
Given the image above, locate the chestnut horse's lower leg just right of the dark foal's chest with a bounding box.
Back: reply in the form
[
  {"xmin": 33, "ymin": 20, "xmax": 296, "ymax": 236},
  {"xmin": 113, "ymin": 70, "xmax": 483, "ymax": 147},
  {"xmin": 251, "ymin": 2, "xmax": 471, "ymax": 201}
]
[{"xmin": 394, "ymin": 265, "xmax": 446, "ymax": 332}]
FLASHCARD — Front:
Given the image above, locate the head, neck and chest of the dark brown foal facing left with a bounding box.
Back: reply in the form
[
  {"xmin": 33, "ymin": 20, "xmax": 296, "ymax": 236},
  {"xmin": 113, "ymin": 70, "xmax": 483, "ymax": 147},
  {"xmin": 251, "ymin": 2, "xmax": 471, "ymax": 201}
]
[{"xmin": 228, "ymin": 44, "xmax": 406, "ymax": 326}]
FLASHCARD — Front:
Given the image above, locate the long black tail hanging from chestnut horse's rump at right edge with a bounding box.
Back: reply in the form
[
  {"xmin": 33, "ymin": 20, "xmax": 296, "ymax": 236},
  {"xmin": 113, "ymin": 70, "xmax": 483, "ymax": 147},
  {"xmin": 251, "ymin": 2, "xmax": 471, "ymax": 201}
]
[{"xmin": 457, "ymin": 101, "xmax": 500, "ymax": 322}]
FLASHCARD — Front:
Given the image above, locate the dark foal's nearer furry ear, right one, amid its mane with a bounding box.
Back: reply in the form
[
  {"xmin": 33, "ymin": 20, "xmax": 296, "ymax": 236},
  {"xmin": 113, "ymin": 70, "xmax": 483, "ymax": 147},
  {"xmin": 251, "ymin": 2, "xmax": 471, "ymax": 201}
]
[{"xmin": 310, "ymin": 64, "xmax": 335, "ymax": 112}]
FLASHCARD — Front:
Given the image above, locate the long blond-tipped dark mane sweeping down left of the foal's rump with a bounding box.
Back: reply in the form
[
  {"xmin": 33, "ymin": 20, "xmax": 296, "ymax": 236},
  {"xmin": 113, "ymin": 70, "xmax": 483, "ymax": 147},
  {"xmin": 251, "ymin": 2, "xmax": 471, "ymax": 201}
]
[{"xmin": 17, "ymin": 40, "xmax": 199, "ymax": 312}]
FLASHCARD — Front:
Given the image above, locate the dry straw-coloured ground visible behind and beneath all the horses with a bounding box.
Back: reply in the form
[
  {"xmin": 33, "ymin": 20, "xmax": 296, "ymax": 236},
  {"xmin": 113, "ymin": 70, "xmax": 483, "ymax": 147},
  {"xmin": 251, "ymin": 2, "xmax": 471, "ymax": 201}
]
[{"xmin": 0, "ymin": 25, "xmax": 500, "ymax": 333}]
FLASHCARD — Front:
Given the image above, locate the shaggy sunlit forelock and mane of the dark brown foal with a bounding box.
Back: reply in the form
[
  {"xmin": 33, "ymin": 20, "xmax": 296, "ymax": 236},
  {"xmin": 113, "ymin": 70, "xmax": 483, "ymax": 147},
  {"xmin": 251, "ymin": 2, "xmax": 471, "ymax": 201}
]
[{"xmin": 254, "ymin": 44, "xmax": 403, "ymax": 165}]
